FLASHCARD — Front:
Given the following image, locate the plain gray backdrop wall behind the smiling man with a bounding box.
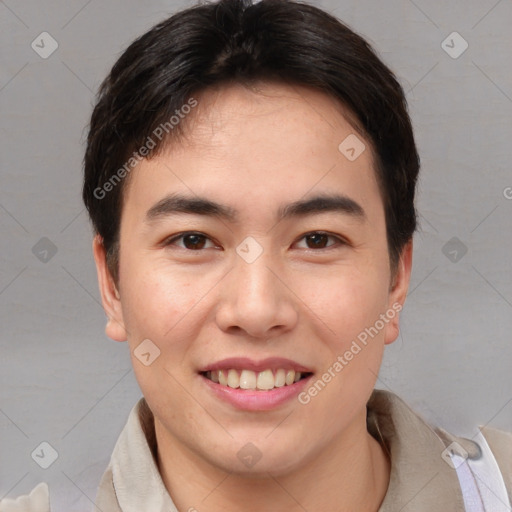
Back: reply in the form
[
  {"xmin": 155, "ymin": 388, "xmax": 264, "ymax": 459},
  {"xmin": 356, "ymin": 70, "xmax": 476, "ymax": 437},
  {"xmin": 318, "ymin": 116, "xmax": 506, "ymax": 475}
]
[{"xmin": 0, "ymin": 0, "xmax": 512, "ymax": 511}]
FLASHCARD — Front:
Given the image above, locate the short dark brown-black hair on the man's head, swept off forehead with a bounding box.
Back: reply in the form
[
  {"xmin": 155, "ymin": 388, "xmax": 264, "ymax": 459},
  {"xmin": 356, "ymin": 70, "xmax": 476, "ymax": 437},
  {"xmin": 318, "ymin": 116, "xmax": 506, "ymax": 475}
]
[{"xmin": 82, "ymin": 0, "xmax": 420, "ymax": 284}]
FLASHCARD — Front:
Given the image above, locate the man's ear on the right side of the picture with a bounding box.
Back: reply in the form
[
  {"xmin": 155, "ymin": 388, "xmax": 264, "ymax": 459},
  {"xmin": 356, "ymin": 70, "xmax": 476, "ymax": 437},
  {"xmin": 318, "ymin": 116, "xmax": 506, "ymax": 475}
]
[{"xmin": 384, "ymin": 239, "xmax": 413, "ymax": 345}]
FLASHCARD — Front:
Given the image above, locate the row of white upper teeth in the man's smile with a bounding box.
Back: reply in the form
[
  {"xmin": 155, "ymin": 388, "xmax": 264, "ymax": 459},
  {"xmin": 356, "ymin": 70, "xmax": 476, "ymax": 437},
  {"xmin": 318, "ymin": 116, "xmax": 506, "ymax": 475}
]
[{"xmin": 206, "ymin": 368, "xmax": 302, "ymax": 391}]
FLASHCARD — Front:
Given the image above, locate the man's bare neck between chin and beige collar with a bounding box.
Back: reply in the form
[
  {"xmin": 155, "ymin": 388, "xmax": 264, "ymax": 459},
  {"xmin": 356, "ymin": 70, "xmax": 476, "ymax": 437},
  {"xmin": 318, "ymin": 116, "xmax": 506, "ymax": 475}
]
[{"xmin": 155, "ymin": 410, "xmax": 390, "ymax": 512}]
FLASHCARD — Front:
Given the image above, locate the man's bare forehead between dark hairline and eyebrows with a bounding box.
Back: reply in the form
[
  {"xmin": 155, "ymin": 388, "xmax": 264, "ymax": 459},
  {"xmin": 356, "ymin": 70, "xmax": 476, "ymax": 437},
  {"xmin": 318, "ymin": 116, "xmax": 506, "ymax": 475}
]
[{"xmin": 125, "ymin": 83, "xmax": 378, "ymax": 224}]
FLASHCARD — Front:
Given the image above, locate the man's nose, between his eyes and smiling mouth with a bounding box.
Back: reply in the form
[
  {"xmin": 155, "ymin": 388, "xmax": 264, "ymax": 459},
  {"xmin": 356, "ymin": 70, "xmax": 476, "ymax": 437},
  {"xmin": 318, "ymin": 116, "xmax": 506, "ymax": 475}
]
[{"xmin": 216, "ymin": 248, "xmax": 298, "ymax": 340}]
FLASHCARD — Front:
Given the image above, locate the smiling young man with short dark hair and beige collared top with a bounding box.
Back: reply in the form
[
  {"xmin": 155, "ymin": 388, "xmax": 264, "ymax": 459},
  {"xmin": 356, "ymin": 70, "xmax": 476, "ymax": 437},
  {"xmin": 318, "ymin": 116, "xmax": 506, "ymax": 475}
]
[{"xmin": 3, "ymin": 0, "xmax": 512, "ymax": 512}]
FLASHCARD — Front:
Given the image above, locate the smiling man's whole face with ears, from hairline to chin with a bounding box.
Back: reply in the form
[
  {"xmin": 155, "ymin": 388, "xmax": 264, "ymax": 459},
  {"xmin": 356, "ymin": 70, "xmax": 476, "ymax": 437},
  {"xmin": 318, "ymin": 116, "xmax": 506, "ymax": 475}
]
[{"xmin": 94, "ymin": 80, "xmax": 411, "ymax": 474}]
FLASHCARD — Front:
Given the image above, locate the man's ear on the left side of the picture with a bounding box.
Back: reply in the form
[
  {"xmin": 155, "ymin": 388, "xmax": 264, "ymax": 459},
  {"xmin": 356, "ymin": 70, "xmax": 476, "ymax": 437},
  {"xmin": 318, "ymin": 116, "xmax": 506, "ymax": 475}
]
[{"xmin": 92, "ymin": 235, "xmax": 127, "ymax": 341}]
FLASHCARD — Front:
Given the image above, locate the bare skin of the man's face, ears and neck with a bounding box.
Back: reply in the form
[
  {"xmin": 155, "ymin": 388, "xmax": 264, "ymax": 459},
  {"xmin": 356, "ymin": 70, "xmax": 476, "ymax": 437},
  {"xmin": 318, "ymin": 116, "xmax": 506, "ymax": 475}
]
[{"xmin": 93, "ymin": 83, "xmax": 412, "ymax": 512}]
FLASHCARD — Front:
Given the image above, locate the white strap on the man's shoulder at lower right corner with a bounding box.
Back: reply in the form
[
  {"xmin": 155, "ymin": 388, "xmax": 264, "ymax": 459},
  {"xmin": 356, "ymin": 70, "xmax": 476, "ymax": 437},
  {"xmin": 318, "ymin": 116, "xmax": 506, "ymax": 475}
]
[{"xmin": 450, "ymin": 432, "xmax": 512, "ymax": 512}]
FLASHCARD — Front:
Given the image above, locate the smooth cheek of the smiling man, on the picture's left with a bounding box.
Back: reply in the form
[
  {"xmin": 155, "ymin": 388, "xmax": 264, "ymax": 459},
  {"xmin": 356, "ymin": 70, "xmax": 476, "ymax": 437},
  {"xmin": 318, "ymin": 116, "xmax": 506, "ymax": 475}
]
[{"xmin": 122, "ymin": 258, "xmax": 201, "ymax": 410}]
